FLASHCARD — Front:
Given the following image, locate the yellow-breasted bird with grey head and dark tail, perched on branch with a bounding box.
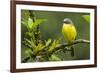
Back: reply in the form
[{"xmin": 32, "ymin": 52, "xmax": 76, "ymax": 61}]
[{"xmin": 62, "ymin": 18, "xmax": 77, "ymax": 56}]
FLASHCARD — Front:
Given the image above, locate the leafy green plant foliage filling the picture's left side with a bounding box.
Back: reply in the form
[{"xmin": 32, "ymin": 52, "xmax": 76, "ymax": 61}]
[{"xmin": 21, "ymin": 11, "xmax": 60, "ymax": 61}]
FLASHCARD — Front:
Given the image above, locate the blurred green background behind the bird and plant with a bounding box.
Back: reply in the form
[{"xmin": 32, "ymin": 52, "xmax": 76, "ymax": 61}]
[{"xmin": 21, "ymin": 10, "xmax": 90, "ymax": 60}]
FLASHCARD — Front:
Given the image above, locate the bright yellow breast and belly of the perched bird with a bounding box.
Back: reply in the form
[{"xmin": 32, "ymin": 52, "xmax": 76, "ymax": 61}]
[{"xmin": 62, "ymin": 24, "xmax": 77, "ymax": 43}]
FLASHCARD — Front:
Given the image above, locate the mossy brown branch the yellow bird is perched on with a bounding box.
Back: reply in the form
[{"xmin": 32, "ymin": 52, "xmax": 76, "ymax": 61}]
[{"xmin": 22, "ymin": 39, "xmax": 90, "ymax": 63}]
